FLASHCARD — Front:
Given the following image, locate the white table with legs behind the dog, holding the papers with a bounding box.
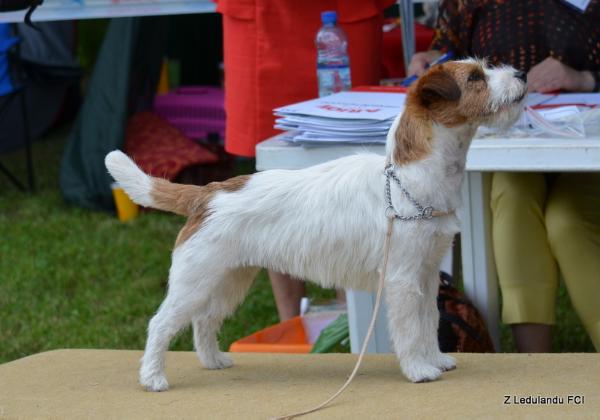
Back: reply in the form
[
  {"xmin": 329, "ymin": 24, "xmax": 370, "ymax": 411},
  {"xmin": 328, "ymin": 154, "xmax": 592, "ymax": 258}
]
[{"xmin": 256, "ymin": 136, "xmax": 600, "ymax": 353}]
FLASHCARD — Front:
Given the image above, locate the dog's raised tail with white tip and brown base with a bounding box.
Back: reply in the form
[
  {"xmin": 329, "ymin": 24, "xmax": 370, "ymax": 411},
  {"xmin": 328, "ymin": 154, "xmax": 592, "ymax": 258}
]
[{"xmin": 104, "ymin": 150, "xmax": 207, "ymax": 216}]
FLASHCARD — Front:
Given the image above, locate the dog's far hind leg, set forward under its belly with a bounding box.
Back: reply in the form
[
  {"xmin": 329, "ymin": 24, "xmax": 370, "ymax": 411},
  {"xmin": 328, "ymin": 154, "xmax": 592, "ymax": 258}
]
[{"xmin": 192, "ymin": 267, "xmax": 258, "ymax": 369}]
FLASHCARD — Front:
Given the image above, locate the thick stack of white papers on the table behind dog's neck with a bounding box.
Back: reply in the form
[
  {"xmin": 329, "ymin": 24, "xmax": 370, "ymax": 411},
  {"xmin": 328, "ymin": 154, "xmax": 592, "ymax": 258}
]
[{"xmin": 274, "ymin": 92, "xmax": 406, "ymax": 144}]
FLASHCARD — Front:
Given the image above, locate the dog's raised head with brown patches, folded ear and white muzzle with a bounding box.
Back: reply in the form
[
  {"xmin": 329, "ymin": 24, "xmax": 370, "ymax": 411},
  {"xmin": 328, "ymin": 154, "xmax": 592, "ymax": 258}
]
[{"xmin": 393, "ymin": 59, "xmax": 527, "ymax": 164}]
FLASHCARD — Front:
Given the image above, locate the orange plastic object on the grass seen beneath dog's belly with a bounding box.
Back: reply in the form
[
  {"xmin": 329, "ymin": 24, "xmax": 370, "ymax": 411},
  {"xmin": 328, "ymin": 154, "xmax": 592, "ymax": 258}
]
[{"xmin": 229, "ymin": 316, "xmax": 312, "ymax": 353}]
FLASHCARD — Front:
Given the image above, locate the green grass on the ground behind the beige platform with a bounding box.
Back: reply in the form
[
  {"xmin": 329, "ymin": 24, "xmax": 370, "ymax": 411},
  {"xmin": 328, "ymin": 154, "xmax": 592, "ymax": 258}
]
[{"xmin": 0, "ymin": 128, "xmax": 593, "ymax": 363}]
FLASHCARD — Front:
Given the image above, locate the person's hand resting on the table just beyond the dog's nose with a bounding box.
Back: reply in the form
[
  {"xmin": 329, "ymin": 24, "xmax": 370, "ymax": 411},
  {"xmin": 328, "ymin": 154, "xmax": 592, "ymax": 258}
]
[{"xmin": 527, "ymin": 57, "xmax": 594, "ymax": 93}]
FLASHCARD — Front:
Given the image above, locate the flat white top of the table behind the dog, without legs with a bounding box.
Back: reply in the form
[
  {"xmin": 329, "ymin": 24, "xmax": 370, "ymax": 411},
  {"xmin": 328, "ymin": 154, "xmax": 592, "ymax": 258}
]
[{"xmin": 256, "ymin": 136, "xmax": 600, "ymax": 172}]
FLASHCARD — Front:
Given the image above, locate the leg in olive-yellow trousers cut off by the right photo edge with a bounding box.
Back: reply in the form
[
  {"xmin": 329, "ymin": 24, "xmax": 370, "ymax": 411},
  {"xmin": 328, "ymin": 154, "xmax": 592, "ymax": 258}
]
[{"xmin": 546, "ymin": 173, "xmax": 600, "ymax": 351}]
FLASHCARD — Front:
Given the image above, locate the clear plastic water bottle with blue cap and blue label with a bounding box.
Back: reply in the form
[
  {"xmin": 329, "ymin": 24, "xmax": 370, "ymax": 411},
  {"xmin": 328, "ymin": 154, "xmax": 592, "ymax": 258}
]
[{"xmin": 315, "ymin": 12, "xmax": 351, "ymax": 96}]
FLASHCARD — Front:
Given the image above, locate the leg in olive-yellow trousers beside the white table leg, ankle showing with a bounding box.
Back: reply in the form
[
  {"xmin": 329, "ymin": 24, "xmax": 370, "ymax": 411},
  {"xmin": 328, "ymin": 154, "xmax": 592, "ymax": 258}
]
[{"xmin": 491, "ymin": 172, "xmax": 558, "ymax": 352}]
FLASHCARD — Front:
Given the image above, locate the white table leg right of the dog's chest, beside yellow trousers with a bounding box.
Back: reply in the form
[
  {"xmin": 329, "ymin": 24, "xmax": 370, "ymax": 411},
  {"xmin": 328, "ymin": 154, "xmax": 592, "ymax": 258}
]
[{"xmin": 460, "ymin": 172, "xmax": 500, "ymax": 351}]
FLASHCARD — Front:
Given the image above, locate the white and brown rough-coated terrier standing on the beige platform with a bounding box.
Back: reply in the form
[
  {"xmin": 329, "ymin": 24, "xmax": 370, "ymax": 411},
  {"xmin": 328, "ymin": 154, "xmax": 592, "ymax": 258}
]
[{"xmin": 106, "ymin": 59, "xmax": 527, "ymax": 391}]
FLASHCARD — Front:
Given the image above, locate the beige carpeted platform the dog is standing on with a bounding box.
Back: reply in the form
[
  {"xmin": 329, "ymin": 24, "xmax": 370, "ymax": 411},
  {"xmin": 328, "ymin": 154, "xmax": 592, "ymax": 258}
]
[{"xmin": 0, "ymin": 350, "xmax": 600, "ymax": 419}]
